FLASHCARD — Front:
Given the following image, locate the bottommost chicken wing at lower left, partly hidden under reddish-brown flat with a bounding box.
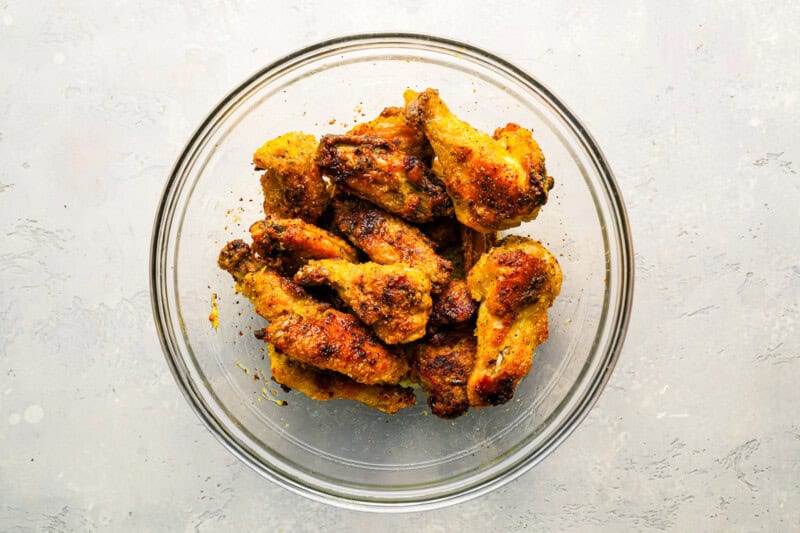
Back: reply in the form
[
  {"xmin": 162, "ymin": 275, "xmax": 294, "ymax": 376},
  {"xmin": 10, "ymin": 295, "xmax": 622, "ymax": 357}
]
[{"xmin": 270, "ymin": 349, "xmax": 416, "ymax": 414}]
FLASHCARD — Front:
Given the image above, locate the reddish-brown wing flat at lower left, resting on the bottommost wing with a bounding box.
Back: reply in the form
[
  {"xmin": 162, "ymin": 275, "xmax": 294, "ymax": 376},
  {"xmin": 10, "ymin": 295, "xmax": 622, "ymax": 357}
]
[{"xmin": 257, "ymin": 309, "xmax": 409, "ymax": 385}]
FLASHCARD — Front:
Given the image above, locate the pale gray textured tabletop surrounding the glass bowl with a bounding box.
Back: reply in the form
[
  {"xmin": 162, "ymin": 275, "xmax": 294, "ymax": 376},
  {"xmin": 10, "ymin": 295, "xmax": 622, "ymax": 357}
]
[{"xmin": 0, "ymin": 0, "xmax": 800, "ymax": 531}]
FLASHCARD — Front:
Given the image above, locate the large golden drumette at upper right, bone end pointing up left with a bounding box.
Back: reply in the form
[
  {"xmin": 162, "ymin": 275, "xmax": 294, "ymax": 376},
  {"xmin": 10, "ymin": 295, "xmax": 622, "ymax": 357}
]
[{"xmin": 406, "ymin": 89, "xmax": 553, "ymax": 233}]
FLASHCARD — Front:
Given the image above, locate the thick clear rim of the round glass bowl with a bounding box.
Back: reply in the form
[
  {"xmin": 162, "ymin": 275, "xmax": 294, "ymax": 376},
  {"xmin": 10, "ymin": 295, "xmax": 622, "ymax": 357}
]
[{"xmin": 149, "ymin": 33, "xmax": 634, "ymax": 512}]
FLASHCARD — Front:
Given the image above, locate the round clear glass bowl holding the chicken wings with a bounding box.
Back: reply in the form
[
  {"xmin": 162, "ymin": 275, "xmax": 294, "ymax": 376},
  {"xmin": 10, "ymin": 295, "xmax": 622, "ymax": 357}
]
[{"xmin": 151, "ymin": 34, "xmax": 633, "ymax": 511}]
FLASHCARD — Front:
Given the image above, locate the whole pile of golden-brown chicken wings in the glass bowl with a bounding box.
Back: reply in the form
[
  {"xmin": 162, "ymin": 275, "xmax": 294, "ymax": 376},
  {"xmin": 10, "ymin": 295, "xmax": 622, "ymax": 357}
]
[{"xmin": 218, "ymin": 89, "xmax": 561, "ymax": 418}]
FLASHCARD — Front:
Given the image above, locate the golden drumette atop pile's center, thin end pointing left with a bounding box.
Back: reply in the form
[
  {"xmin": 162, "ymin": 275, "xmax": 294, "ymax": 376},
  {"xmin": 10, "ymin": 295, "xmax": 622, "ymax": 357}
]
[{"xmin": 294, "ymin": 259, "xmax": 432, "ymax": 344}]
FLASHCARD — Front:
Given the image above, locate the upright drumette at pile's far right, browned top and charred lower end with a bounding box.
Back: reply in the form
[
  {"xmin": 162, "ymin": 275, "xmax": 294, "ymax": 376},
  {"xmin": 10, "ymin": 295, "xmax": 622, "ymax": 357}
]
[{"xmin": 467, "ymin": 237, "xmax": 561, "ymax": 407}]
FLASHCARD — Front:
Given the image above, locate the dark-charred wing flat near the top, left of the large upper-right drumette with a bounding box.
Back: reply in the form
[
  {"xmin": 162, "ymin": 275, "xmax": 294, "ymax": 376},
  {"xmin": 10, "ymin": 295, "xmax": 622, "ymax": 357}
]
[{"xmin": 317, "ymin": 135, "xmax": 453, "ymax": 223}]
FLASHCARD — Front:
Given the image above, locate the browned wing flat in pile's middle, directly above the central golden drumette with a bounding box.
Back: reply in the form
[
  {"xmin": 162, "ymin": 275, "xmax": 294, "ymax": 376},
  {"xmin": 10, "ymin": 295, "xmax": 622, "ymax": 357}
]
[{"xmin": 333, "ymin": 198, "xmax": 453, "ymax": 294}]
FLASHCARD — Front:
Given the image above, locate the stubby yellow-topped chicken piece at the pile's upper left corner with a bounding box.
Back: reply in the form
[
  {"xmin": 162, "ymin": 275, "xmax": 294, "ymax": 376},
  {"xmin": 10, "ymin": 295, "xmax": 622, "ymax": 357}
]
[{"xmin": 253, "ymin": 132, "xmax": 331, "ymax": 222}]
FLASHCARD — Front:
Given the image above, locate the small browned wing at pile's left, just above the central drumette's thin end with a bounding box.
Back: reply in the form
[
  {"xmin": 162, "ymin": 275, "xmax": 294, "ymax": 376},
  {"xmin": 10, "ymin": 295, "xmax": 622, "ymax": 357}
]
[{"xmin": 250, "ymin": 215, "xmax": 358, "ymax": 264}]
